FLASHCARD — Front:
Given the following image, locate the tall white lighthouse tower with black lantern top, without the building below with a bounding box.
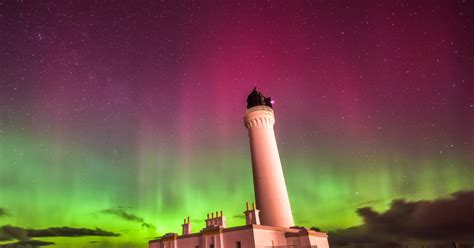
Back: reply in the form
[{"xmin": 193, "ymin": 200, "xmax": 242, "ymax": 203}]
[{"xmin": 244, "ymin": 88, "xmax": 294, "ymax": 228}]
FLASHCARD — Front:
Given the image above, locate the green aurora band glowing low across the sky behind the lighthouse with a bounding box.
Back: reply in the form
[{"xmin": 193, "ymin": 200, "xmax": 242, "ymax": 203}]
[{"xmin": 0, "ymin": 128, "xmax": 473, "ymax": 247}]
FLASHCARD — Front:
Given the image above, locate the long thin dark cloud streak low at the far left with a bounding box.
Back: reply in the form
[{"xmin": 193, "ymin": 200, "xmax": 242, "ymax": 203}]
[{"xmin": 0, "ymin": 225, "xmax": 120, "ymax": 241}]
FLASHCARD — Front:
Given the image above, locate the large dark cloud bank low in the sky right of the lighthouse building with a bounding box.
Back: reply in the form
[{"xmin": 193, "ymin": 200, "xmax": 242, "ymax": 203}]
[{"xmin": 330, "ymin": 191, "xmax": 474, "ymax": 247}]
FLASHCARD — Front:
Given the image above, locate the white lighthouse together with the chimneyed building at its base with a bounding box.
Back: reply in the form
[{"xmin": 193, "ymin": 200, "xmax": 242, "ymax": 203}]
[{"xmin": 149, "ymin": 89, "xmax": 329, "ymax": 248}]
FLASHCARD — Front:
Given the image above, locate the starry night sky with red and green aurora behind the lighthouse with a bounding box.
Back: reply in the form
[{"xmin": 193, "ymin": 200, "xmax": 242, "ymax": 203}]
[{"xmin": 0, "ymin": 0, "xmax": 474, "ymax": 247}]
